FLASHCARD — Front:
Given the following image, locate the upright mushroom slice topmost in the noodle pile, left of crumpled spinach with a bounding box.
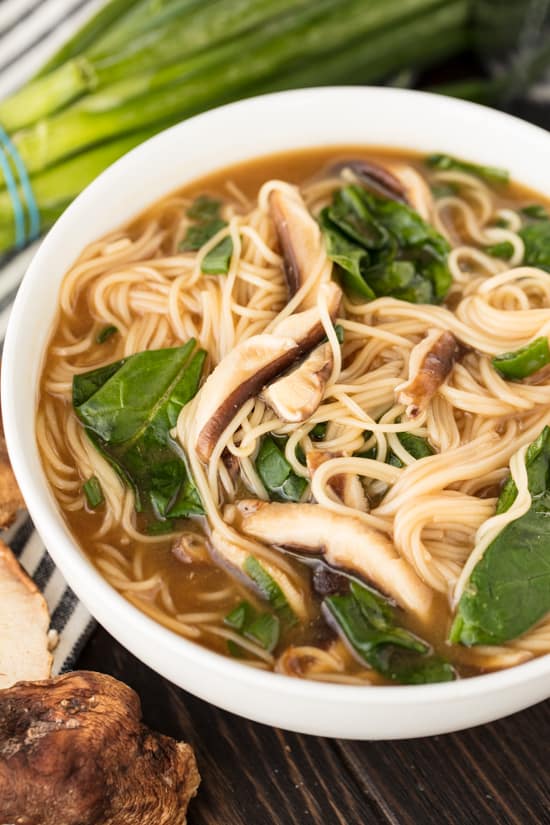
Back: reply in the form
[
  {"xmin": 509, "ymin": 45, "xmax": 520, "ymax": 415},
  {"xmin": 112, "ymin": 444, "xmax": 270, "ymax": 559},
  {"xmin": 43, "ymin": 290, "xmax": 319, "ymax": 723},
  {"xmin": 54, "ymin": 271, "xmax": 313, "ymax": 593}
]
[{"xmin": 269, "ymin": 189, "xmax": 322, "ymax": 308}]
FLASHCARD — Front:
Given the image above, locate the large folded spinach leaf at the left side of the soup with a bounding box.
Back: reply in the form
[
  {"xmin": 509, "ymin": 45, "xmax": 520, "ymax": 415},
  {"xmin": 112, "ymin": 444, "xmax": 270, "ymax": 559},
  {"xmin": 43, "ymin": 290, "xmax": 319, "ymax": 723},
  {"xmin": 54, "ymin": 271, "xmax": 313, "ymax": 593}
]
[{"xmin": 73, "ymin": 340, "xmax": 206, "ymax": 529}]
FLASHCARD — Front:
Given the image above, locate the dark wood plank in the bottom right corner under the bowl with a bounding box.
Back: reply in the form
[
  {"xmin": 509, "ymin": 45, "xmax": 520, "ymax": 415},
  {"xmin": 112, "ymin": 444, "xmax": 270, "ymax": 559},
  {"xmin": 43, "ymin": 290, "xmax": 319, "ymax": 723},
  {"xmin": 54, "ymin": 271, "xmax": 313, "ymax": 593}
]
[{"xmin": 338, "ymin": 702, "xmax": 550, "ymax": 825}]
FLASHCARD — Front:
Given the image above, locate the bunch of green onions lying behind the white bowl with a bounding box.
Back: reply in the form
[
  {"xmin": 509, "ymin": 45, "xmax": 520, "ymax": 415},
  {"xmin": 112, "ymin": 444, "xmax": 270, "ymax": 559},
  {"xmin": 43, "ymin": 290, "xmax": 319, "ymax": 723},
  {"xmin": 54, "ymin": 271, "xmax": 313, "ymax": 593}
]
[{"xmin": 0, "ymin": 0, "xmax": 469, "ymax": 253}]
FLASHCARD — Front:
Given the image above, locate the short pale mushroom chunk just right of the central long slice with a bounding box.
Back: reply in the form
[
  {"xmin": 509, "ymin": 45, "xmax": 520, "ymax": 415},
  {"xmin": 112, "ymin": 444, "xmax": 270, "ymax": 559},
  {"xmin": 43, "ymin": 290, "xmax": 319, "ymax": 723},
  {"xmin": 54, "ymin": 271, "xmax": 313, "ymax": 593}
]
[{"xmin": 261, "ymin": 343, "xmax": 334, "ymax": 424}]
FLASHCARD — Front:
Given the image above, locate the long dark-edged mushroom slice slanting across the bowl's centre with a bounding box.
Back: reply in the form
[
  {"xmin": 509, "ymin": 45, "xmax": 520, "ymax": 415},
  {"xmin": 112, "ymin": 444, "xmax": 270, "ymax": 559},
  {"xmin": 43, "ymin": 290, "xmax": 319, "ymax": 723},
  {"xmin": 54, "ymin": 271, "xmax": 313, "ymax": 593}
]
[{"xmin": 194, "ymin": 283, "xmax": 342, "ymax": 462}]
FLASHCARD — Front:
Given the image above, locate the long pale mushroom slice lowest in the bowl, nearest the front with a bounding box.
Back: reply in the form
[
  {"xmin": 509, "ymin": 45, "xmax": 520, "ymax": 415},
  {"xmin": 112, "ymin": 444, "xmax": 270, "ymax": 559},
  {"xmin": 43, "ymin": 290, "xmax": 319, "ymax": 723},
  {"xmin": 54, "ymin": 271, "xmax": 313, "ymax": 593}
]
[{"xmin": 237, "ymin": 499, "xmax": 433, "ymax": 623}]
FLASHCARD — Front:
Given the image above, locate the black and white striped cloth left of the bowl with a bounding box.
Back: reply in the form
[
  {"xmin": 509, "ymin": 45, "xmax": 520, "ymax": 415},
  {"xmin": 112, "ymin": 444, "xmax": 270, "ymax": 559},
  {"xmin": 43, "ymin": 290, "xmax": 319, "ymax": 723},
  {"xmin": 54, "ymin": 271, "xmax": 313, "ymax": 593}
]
[{"xmin": 0, "ymin": 0, "xmax": 103, "ymax": 673}]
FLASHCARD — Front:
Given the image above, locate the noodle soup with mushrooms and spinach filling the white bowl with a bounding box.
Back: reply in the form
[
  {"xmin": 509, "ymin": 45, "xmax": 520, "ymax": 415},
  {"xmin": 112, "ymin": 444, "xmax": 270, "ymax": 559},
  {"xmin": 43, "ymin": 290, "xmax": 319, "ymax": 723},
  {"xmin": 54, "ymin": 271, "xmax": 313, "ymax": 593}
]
[{"xmin": 41, "ymin": 146, "xmax": 550, "ymax": 685}]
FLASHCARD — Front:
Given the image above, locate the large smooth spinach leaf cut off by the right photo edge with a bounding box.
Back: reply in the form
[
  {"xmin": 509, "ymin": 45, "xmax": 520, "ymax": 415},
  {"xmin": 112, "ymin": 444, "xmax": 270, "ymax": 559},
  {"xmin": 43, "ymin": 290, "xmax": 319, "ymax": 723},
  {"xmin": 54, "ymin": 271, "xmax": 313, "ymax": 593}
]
[{"xmin": 449, "ymin": 427, "xmax": 550, "ymax": 645}]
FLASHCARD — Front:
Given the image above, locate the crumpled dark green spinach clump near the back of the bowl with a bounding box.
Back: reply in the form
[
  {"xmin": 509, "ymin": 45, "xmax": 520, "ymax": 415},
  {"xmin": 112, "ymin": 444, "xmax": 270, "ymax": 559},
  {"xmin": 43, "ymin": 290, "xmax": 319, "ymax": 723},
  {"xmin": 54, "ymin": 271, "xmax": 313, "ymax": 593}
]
[{"xmin": 319, "ymin": 185, "xmax": 451, "ymax": 303}]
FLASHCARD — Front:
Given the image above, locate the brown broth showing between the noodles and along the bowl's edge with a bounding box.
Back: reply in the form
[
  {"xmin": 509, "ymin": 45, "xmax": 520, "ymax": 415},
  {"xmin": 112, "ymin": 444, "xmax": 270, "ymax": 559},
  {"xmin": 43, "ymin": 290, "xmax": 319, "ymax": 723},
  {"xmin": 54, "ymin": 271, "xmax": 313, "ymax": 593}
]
[{"xmin": 38, "ymin": 146, "xmax": 548, "ymax": 683}]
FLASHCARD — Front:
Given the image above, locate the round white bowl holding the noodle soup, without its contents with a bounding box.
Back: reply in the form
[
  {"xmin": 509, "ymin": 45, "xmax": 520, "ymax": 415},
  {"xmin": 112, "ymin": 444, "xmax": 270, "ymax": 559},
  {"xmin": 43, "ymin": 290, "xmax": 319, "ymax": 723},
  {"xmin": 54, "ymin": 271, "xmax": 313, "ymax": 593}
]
[{"xmin": 2, "ymin": 88, "xmax": 550, "ymax": 739}]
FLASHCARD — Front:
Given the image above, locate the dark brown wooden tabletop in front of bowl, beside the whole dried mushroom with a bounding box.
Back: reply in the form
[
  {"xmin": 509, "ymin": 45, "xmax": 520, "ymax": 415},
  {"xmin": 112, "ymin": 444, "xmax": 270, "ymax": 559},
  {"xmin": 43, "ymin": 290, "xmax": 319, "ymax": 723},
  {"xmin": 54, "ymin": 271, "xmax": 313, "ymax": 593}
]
[{"xmin": 77, "ymin": 629, "xmax": 550, "ymax": 825}]
